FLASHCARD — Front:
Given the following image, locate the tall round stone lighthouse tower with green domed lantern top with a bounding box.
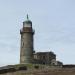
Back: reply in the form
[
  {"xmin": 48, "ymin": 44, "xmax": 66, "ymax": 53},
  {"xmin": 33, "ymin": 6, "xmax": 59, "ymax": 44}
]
[{"xmin": 20, "ymin": 15, "xmax": 34, "ymax": 64}]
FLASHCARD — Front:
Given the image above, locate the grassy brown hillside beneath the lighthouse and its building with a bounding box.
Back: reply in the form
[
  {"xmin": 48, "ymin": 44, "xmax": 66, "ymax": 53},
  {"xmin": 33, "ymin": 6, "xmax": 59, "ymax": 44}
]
[{"xmin": 0, "ymin": 64, "xmax": 75, "ymax": 75}]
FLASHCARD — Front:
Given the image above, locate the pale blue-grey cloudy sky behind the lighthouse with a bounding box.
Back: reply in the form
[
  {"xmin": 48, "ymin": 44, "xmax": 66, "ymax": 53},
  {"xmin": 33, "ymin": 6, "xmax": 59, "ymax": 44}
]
[{"xmin": 0, "ymin": 0, "xmax": 75, "ymax": 66}]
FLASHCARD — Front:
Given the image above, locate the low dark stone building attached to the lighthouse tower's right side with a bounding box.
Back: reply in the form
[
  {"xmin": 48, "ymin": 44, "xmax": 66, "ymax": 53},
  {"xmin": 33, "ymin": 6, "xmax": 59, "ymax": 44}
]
[{"xmin": 34, "ymin": 52, "xmax": 56, "ymax": 65}]
